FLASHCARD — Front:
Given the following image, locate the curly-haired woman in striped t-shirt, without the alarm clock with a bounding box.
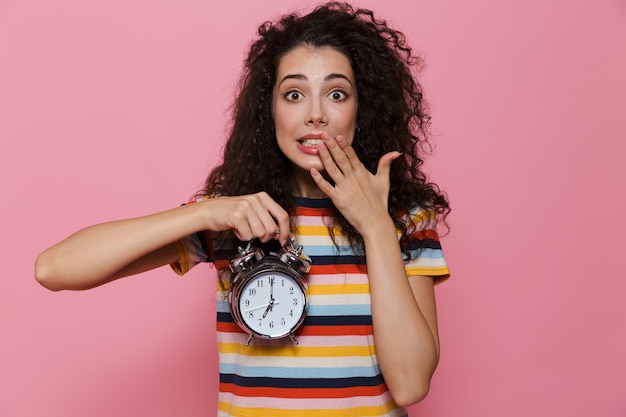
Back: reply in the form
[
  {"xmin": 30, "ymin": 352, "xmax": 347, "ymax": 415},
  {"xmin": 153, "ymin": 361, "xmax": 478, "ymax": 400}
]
[{"xmin": 36, "ymin": 3, "xmax": 449, "ymax": 416}]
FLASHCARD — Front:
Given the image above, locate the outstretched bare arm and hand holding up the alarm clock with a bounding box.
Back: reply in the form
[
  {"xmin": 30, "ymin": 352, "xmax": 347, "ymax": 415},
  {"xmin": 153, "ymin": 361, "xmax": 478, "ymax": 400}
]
[{"xmin": 35, "ymin": 193, "xmax": 290, "ymax": 291}]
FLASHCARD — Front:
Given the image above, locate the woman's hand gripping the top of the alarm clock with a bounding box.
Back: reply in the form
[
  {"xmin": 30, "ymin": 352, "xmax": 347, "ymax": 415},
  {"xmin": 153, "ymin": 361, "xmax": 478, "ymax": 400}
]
[{"xmin": 198, "ymin": 192, "xmax": 291, "ymax": 245}]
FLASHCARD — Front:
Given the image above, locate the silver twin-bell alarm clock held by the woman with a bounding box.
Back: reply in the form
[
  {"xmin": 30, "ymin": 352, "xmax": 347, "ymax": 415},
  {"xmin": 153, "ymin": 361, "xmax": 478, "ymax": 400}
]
[{"xmin": 228, "ymin": 240, "xmax": 311, "ymax": 346}]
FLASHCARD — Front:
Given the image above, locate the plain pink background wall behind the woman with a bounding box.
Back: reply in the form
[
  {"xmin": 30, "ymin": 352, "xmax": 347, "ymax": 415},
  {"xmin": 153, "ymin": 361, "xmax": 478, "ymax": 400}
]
[{"xmin": 0, "ymin": 0, "xmax": 626, "ymax": 417}]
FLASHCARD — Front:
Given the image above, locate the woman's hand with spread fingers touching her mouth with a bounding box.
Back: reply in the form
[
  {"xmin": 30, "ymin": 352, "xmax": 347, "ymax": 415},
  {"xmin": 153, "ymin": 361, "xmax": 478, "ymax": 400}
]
[{"xmin": 311, "ymin": 133, "xmax": 401, "ymax": 235}]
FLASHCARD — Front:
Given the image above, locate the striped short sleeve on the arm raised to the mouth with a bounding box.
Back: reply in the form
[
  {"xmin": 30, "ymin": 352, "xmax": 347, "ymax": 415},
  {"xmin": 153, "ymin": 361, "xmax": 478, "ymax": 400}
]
[{"xmin": 403, "ymin": 209, "xmax": 450, "ymax": 284}]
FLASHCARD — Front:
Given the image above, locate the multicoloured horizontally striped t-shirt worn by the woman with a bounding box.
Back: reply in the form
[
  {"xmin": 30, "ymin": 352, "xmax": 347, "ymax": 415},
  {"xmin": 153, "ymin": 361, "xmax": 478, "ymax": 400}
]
[{"xmin": 172, "ymin": 198, "xmax": 449, "ymax": 417}]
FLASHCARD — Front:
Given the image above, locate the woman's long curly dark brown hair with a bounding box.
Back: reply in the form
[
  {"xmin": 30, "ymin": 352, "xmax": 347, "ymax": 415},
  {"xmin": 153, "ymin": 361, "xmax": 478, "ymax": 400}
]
[{"xmin": 201, "ymin": 2, "xmax": 450, "ymax": 253}]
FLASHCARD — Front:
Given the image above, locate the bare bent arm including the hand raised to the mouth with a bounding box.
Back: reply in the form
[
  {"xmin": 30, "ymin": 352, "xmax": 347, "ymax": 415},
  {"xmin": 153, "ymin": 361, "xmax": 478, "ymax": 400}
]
[{"xmin": 311, "ymin": 136, "xmax": 439, "ymax": 406}]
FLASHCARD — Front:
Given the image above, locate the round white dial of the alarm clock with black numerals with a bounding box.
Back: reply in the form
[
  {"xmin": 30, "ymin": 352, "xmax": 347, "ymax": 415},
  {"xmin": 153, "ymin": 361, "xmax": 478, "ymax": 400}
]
[{"xmin": 239, "ymin": 271, "xmax": 306, "ymax": 337}]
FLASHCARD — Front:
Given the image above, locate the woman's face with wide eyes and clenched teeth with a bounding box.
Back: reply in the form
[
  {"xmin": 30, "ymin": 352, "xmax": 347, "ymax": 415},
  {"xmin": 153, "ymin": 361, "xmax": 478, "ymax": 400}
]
[{"xmin": 272, "ymin": 46, "xmax": 357, "ymax": 177}]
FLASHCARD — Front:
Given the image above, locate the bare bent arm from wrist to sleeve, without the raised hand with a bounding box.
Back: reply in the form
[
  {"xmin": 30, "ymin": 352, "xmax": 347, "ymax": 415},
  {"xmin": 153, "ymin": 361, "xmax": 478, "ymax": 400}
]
[{"xmin": 363, "ymin": 220, "xmax": 439, "ymax": 406}]
